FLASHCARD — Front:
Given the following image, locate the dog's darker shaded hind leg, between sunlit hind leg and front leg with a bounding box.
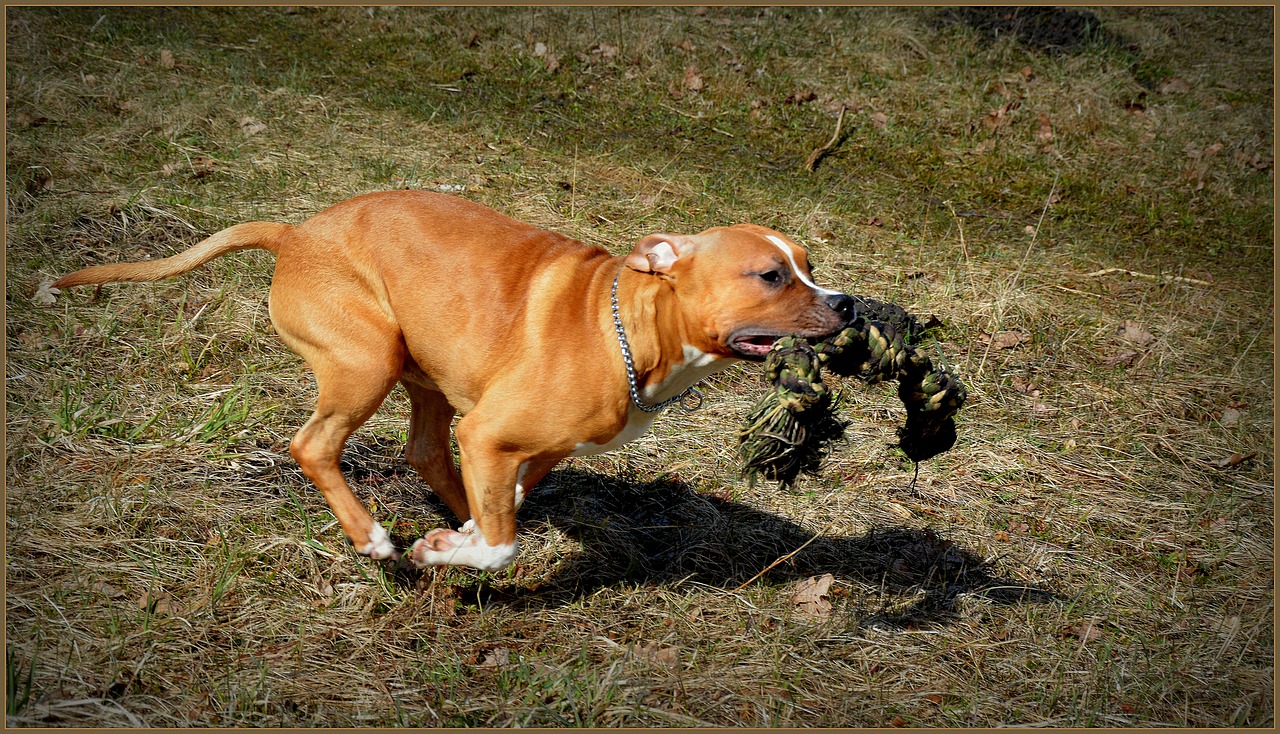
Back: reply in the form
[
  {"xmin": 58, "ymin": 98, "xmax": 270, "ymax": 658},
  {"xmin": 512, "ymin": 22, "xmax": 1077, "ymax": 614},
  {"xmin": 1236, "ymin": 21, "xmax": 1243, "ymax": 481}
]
[{"xmin": 401, "ymin": 375, "xmax": 471, "ymax": 523}]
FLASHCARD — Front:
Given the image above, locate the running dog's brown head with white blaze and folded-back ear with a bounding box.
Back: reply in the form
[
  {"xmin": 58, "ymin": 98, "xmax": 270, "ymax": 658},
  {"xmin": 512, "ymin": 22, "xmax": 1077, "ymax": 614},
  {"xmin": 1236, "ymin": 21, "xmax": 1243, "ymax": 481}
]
[{"xmin": 626, "ymin": 224, "xmax": 856, "ymax": 360}]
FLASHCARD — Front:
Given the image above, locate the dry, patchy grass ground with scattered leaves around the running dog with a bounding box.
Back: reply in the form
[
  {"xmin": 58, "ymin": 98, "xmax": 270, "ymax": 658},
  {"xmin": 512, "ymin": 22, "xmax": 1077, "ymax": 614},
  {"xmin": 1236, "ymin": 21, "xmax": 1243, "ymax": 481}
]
[{"xmin": 5, "ymin": 6, "xmax": 1275, "ymax": 726}]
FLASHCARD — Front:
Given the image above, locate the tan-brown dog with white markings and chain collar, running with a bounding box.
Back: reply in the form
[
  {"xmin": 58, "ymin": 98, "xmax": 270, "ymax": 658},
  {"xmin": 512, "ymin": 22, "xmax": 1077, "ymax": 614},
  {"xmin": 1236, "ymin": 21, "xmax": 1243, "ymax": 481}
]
[{"xmin": 54, "ymin": 191, "xmax": 854, "ymax": 570}]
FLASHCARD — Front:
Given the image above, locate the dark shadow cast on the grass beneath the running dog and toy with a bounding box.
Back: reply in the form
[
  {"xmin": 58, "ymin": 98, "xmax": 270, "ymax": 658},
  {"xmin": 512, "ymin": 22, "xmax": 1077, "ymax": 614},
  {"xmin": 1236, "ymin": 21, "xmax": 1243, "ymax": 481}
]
[{"xmin": 384, "ymin": 468, "xmax": 1056, "ymax": 626}]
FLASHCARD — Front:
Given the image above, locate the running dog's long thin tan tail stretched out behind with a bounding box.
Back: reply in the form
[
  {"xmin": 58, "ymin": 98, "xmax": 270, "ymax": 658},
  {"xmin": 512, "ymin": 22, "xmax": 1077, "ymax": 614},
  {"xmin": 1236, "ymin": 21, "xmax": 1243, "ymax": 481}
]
[{"xmin": 54, "ymin": 222, "xmax": 293, "ymax": 288}]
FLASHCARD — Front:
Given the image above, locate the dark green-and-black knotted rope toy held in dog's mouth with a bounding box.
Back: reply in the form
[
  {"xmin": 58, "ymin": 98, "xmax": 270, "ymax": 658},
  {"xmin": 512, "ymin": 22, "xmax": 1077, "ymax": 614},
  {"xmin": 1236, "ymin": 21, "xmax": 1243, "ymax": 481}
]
[{"xmin": 737, "ymin": 297, "xmax": 966, "ymax": 485}]
